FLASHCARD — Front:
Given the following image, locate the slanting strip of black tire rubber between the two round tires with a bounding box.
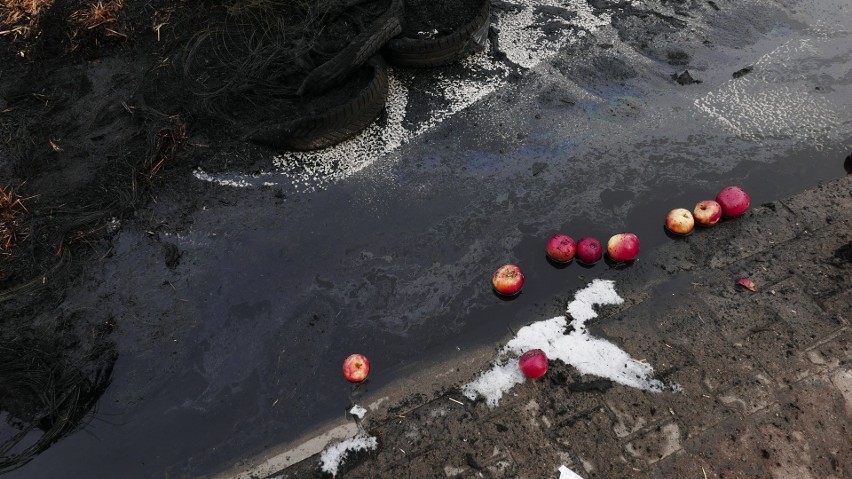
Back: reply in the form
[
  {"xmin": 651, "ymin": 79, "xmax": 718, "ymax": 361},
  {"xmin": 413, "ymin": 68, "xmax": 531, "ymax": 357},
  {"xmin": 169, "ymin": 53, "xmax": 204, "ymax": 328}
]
[{"xmin": 297, "ymin": 0, "xmax": 402, "ymax": 95}]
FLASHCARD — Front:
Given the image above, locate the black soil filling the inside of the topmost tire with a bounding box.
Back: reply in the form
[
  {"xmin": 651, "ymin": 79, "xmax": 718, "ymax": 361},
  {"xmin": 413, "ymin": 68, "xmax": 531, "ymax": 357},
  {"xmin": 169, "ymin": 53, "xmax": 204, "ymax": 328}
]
[{"xmin": 402, "ymin": 0, "xmax": 482, "ymax": 38}]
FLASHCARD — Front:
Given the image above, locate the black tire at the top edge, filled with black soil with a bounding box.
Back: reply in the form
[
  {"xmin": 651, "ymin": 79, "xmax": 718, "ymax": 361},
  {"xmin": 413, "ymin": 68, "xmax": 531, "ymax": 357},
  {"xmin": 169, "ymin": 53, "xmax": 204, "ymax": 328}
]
[{"xmin": 382, "ymin": 0, "xmax": 491, "ymax": 68}]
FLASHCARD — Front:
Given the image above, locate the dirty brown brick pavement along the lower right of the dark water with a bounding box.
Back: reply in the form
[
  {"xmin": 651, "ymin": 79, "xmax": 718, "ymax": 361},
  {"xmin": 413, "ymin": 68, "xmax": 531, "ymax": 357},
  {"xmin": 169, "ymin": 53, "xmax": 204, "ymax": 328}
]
[{"xmin": 268, "ymin": 176, "xmax": 852, "ymax": 479}]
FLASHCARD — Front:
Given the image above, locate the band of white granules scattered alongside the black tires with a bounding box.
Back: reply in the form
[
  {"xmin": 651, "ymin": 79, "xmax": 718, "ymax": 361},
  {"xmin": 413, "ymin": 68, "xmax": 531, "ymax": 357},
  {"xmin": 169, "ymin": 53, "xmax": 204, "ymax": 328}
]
[{"xmin": 195, "ymin": 0, "xmax": 610, "ymax": 191}]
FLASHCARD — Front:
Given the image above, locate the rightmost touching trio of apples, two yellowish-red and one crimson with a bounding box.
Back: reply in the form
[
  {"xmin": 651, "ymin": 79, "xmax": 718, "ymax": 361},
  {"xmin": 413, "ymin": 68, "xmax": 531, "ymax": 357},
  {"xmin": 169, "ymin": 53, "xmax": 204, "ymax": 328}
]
[{"xmin": 666, "ymin": 186, "xmax": 751, "ymax": 236}]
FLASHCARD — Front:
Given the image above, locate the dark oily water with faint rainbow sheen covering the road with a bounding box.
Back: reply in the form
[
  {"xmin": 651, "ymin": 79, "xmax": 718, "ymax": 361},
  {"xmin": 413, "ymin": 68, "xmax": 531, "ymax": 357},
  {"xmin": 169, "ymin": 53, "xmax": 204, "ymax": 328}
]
[{"xmin": 9, "ymin": 1, "xmax": 852, "ymax": 478}]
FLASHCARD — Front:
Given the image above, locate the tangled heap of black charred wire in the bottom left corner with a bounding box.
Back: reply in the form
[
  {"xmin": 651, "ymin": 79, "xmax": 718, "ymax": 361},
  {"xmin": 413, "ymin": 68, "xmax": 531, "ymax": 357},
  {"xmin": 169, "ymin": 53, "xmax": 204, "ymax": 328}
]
[{"xmin": 0, "ymin": 321, "xmax": 117, "ymax": 474}]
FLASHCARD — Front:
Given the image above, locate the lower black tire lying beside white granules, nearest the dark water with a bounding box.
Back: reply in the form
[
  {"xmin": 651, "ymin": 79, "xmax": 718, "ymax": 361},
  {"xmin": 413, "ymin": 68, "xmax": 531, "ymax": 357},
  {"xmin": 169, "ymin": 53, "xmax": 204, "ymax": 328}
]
[{"xmin": 249, "ymin": 55, "xmax": 388, "ymax": 150}]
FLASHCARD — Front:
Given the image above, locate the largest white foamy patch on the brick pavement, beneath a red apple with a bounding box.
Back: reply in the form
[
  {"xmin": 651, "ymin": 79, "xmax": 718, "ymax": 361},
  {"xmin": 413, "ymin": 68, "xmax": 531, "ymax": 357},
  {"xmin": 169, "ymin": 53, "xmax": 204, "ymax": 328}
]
[{"xmin": 462, "ymin": 279, "xmax": 665, "ymax": 407}]
